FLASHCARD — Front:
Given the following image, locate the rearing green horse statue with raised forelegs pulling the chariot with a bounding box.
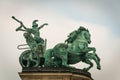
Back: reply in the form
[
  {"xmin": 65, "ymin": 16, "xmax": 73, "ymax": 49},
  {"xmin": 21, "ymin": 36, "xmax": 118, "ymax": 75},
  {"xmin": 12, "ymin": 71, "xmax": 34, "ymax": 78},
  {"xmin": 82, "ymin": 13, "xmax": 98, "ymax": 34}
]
[{"xmin": 44, "ymin": 27, "xmax": 101, "ymax": 71}]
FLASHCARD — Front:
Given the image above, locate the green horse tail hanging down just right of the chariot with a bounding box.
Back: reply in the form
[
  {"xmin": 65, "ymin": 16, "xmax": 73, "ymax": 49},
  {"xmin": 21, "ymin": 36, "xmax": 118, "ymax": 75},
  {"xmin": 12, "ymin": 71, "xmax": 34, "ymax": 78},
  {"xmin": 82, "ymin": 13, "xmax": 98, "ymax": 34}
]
[{"xmin": 44, "ymin": 49, "xmax": 53, "ymax": 67}]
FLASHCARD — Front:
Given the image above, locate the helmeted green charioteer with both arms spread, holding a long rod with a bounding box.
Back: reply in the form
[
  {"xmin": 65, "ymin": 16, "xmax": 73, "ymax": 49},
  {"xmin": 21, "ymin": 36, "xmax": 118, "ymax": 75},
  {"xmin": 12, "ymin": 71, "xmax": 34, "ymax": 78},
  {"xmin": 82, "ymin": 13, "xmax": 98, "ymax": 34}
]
[{"xmin": 12, "ymin": 16, "xmax": 48, "ymax": 53}]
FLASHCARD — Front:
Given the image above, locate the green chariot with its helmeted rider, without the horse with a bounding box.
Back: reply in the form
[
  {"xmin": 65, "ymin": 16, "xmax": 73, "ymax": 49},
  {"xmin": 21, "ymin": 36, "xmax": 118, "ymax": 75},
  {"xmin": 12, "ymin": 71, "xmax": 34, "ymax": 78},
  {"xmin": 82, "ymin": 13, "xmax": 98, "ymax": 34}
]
[{"xmin": 12, "ymin": 16, "xmax": 48, "ymax": 67}]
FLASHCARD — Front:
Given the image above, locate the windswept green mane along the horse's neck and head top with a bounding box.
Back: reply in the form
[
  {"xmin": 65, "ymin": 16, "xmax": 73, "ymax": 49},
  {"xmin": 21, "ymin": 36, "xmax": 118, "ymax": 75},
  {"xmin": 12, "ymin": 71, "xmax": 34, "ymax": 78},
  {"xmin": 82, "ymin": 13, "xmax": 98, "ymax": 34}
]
[{"xmin": 65, "ymin": 26, "xmax": 88, "ymax": 43}]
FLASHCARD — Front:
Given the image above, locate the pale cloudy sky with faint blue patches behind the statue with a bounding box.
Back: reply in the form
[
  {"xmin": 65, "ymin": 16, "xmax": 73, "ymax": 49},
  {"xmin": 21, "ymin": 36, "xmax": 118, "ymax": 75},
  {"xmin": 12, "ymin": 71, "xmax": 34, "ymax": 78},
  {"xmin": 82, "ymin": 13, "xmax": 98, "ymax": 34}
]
[{"xmin": 0, "ymin": 0, "xmax": 120, "ymax": 80}]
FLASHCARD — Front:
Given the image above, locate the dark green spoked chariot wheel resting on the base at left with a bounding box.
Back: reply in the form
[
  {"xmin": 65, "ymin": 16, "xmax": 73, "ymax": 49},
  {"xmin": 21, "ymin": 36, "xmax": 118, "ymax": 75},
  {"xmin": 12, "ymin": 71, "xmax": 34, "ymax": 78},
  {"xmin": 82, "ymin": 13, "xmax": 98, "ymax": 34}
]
[{"xmin": 19, "ymin": 50, "xmax": 40, "ymax": 67}]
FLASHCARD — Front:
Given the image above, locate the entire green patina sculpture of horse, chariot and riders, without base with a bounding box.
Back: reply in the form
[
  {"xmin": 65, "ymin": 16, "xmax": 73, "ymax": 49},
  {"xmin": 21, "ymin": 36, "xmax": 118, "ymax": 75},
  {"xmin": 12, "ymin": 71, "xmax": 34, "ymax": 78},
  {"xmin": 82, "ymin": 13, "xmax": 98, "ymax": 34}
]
[{"xmin": 12, "ymin": 16, "xmax": 101, "ymax": 71}]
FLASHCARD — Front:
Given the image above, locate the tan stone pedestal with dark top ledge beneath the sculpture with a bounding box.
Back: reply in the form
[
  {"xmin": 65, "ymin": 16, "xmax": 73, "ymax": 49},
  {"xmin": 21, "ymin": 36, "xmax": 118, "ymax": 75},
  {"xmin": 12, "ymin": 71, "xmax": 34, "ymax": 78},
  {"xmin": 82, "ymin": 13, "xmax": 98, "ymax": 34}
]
[{"xmin": 19, "ymin": 68, "xmax": 92, "ymax": 80}]
